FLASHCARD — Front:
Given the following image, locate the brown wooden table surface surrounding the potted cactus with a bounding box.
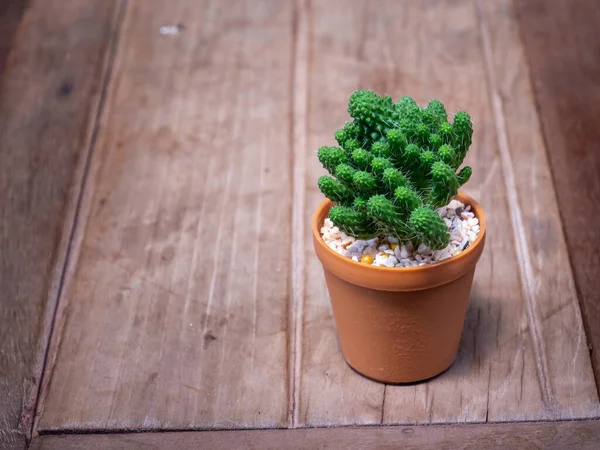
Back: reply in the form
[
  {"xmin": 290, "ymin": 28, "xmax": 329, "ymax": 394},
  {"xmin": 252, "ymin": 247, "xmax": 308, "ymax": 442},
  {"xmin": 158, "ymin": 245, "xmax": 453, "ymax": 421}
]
[{"xmin": 0, "ymin": 0, "xmax": 600, "ymax": 449}]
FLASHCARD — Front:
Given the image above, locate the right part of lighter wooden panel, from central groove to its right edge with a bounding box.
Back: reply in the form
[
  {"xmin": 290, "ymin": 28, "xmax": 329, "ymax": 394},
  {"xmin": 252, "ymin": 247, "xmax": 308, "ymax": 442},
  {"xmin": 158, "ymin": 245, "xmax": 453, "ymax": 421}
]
[{"xmin": 299, "ymin": 1, "xmax": 598, "ymax": 426}]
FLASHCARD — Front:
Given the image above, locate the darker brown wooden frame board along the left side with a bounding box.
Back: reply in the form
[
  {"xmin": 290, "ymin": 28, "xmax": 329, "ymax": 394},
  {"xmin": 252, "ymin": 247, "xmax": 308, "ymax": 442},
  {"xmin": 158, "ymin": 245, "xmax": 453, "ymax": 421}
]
[{"xmin": 0, "ymin": 0, "xmax": 118, "ymax": 448}]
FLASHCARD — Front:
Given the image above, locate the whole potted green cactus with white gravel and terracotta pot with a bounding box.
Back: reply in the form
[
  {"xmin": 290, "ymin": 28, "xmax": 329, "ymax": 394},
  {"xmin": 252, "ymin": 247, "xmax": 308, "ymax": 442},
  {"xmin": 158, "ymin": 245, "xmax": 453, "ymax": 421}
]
[{"xmin": 312, "ymin": 90, "xmax": 485, "ymax": 383}]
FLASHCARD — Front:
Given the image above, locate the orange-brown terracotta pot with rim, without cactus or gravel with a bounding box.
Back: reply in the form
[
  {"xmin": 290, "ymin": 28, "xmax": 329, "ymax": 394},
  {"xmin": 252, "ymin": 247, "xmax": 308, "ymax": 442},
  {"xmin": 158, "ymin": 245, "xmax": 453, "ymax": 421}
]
[{"xmin": 312, "ymin": 192, "xmax": 485, "ymax": 383}]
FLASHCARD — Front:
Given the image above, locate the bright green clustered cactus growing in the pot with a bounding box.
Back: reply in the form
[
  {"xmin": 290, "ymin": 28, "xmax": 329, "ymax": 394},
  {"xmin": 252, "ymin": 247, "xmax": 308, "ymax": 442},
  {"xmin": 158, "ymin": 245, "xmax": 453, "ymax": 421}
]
[{"xmin": 318, "ymin": 90, "xmax": 473, "ymax": 250}]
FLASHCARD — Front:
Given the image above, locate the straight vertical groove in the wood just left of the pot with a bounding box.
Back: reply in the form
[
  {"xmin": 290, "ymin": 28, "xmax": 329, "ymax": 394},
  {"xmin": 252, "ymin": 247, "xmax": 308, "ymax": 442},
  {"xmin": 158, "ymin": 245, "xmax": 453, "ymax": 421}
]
[{"xmin": 288, "ymin": 0, "xmax": 311, "ymax": 428}]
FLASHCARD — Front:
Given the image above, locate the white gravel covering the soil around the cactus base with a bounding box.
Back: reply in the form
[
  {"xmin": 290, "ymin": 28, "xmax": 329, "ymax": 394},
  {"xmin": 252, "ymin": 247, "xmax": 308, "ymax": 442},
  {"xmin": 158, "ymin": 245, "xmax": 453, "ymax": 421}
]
[{"xmin": 321, "ymin": 200, "xmax": 479, "ymax": 267}]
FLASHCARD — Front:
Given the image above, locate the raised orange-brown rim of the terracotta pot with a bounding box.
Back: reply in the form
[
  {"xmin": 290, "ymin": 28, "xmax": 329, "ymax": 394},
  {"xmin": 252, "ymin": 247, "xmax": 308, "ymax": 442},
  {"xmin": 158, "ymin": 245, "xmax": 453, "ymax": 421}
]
[{"xmin": 312, "ymin": 191, "xmax": 486, "ymax": 291}]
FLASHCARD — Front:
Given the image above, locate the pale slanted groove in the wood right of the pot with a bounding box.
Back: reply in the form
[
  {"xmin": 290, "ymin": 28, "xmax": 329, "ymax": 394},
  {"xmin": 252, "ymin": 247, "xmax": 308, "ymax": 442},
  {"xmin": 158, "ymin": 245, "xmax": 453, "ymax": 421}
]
[{"xmin": 475, "ymin": 0, "xmax": 557, "ymax": 412}]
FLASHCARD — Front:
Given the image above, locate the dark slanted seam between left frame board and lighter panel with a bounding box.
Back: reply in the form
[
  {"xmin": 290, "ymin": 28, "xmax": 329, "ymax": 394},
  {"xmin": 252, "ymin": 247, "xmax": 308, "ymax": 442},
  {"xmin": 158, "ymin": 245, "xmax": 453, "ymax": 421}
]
[{"xmin": 29, "ymin": 0, "xmax": 128, "ymax": 439}]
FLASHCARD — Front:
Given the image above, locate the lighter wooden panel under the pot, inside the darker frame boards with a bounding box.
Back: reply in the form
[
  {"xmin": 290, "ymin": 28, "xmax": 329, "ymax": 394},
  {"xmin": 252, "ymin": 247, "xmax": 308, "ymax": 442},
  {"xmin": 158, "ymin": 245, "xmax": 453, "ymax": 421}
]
[{"xmin": 31, "ymin": 0, "xmax": 599, "ymax": 433}]
